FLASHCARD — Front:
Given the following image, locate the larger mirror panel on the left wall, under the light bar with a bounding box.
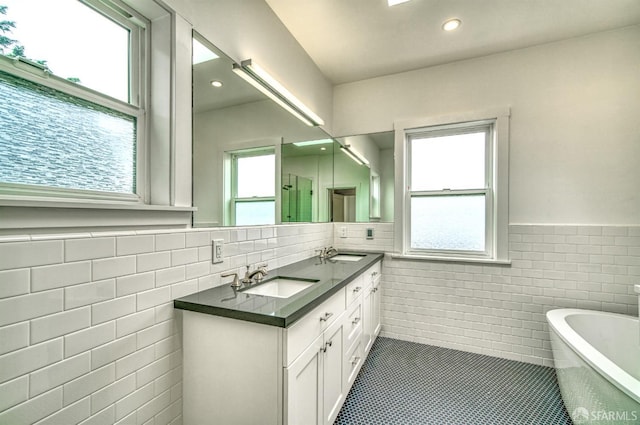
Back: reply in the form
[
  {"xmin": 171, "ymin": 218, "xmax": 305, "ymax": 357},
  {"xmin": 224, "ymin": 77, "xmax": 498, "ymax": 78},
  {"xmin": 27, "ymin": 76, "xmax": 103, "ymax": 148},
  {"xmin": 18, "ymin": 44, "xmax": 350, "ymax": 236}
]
[{"xmin": 193, "ymin": 33, "xmax": 333, "ymax": 227}]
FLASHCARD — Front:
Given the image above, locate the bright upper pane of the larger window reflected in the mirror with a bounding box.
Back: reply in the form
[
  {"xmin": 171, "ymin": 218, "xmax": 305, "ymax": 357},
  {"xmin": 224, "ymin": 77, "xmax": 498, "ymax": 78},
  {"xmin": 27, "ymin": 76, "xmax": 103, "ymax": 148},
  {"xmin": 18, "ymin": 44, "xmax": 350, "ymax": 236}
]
[{"xmin": 236, "ymin": 154, "xmax": 276, "ymax": 197}]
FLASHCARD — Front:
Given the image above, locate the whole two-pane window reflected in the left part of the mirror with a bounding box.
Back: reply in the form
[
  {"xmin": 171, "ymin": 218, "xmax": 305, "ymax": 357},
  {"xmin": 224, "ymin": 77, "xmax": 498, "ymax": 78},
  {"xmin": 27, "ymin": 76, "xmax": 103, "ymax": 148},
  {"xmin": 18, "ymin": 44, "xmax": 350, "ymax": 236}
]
[{"xmin": 230, "ymin": 148, "xmax": 276, "ymax": 226}]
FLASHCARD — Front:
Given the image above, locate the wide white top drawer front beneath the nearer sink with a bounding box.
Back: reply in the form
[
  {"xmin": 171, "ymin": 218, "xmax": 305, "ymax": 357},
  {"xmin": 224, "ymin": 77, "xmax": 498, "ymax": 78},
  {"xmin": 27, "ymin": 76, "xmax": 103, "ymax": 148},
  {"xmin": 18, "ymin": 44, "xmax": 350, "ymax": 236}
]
[{"xmin": 283, "ymin": 288, "xmax": 345, "ymax": 366}]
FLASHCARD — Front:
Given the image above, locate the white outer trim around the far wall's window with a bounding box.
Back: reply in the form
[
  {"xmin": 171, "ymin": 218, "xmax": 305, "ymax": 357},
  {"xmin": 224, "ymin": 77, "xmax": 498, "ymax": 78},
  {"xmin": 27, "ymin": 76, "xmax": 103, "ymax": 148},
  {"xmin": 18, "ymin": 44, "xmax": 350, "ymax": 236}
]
[{"xmin": 392, "ymin": 107, "xmax": 511, "ymax": 264}]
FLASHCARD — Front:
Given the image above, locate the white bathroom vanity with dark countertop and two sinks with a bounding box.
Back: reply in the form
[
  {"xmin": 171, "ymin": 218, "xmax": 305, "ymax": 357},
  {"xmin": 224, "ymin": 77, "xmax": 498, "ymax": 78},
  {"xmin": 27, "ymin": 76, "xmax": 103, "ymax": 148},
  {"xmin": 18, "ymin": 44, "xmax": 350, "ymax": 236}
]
[{"xmin": 174, "ymin": 253, "xmax": 383, "ymax": 425}]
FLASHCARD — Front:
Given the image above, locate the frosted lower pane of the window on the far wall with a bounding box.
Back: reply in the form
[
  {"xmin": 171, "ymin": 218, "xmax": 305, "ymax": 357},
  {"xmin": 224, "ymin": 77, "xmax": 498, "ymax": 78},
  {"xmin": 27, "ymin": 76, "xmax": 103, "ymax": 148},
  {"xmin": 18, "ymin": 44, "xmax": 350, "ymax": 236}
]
[{"xmin": 411, "ymin": 195, "xmax": 485, "ymax": 251}]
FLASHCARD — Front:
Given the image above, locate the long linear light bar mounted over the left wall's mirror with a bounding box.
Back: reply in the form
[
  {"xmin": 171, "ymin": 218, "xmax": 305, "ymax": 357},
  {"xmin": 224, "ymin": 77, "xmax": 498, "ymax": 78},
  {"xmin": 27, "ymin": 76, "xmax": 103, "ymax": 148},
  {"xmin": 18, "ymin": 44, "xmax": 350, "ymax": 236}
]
[{"xmin": 233, "ymin": 59, "xmax": 324, "ymax": 126}]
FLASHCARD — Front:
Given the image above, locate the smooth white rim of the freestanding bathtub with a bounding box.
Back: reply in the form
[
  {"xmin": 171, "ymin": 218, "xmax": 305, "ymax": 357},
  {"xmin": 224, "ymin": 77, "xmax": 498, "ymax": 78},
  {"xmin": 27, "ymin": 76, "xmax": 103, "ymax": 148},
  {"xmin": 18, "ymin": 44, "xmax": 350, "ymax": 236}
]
[{"xmin": 546, "ymin": 308, "xmax": 640, "ymax": 403}]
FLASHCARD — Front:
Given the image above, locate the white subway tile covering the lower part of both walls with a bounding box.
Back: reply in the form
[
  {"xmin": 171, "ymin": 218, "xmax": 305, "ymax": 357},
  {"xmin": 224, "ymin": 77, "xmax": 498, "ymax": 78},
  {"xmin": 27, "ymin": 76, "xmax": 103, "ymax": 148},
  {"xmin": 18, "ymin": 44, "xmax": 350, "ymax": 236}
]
[{"xmin": 0, "ymin": 223, "xmax": 640, "ymax": 425}]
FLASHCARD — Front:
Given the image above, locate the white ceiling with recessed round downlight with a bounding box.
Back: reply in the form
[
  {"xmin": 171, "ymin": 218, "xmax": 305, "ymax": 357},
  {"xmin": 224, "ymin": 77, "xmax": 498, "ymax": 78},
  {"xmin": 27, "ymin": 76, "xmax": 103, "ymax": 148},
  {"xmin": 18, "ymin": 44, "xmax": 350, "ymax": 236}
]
[{"xmin": 265, "ymin": 0, "xmax": 640, "ymax": 84}]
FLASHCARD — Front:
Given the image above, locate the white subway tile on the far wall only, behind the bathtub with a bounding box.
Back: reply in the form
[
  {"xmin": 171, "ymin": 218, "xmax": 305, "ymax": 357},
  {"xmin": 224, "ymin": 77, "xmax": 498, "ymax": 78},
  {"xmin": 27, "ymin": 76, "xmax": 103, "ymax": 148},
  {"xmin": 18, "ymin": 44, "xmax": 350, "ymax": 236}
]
[{"xmin": 376, "ymin": 224, "xmax": 640, "ymax": 366}]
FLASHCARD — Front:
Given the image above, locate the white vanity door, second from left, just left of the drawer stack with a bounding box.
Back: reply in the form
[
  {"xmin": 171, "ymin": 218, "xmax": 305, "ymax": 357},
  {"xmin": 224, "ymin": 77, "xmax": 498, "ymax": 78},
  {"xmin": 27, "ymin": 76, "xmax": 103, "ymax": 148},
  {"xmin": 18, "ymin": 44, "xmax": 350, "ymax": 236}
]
[{"xmin": 322, "ymin": 319, "xmax": 345, "ymax": 425}]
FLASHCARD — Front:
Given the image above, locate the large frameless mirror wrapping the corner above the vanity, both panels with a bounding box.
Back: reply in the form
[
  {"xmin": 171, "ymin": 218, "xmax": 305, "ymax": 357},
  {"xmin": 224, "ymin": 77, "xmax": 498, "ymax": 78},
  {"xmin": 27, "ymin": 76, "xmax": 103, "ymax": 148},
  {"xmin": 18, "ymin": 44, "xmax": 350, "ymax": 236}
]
[{"xmin": 193, "ymin": 32, "xmax": 394, "ymax": 227}]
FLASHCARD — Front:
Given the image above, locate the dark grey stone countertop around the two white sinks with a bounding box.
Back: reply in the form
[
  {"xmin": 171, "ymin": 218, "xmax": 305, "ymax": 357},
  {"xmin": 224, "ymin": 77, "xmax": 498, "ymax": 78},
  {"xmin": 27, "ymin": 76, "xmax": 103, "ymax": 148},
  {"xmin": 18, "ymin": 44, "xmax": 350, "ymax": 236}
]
[{"xmin": 173, "ymin": 252, "xmax": 384, "ymax": 328}]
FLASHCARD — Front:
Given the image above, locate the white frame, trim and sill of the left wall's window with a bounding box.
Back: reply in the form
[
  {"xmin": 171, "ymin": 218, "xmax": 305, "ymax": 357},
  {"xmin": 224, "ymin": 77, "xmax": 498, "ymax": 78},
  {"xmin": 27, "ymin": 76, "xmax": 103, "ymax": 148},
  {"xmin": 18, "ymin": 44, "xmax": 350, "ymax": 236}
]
[{"xmin": 0, "ymin": 0, "xmax": 196, "ymax": 235}]
